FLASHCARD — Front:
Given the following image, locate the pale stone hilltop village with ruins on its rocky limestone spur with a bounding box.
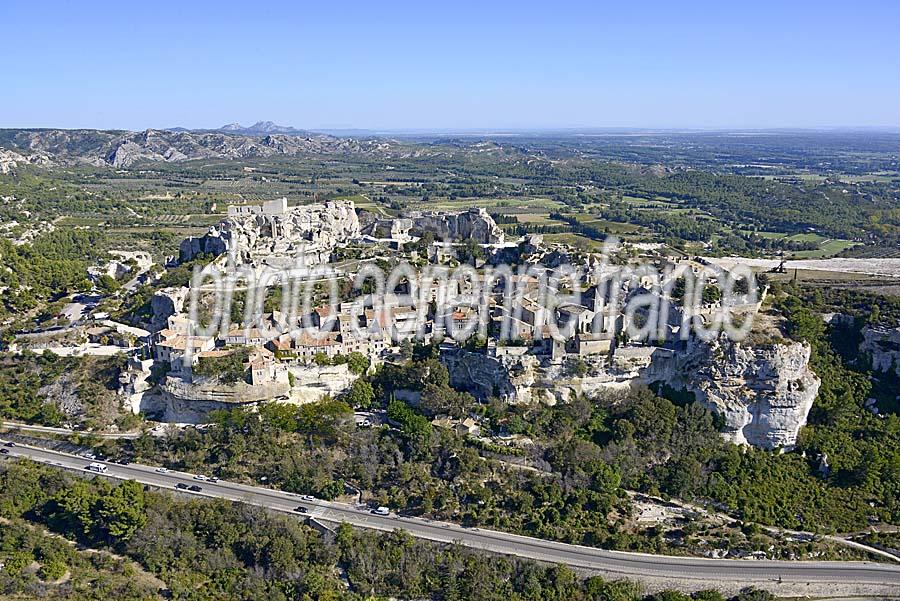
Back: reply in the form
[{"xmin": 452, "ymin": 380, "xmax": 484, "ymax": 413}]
[{"xmin": 44, "ymin": 199, "xmax": 819, "ymax": 448}]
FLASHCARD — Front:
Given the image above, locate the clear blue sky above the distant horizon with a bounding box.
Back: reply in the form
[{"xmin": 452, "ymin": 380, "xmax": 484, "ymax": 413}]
[{"xmin": 0, "ymin": 0, "xmax": 900, "ymax": 129}]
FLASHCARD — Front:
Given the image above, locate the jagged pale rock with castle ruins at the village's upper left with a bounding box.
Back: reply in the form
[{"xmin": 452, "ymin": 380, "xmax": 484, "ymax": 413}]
[{"xmin": 179, "ymin": 201, "xmax": 360, "ymax": 266}]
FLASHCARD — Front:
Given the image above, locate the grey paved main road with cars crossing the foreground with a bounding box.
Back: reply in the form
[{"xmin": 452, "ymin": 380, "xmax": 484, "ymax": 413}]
[{"xmin": 7, "ymin": 445, "xmax": 900, "ymax": 597}]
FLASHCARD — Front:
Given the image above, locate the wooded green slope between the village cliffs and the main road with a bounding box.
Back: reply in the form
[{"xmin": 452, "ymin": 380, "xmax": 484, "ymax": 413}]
[{"xmin": 102, "ymin": 330, "xmax": 898, "ymax": 556}]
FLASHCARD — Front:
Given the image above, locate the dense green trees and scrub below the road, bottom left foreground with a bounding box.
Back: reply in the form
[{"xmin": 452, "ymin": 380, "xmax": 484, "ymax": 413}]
[{"xmin": 0, "ymin": 462, "xmax": 773, "ymax": 601}]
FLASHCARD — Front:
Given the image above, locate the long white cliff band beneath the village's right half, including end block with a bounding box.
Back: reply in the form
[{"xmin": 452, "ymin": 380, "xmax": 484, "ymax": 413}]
[{"xmin": 441, "ymin": 342, "xmax": 821, "ymax": 449}]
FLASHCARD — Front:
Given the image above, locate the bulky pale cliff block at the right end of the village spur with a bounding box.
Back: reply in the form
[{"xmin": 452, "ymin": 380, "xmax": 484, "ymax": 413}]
[{"xmin": 656, "ymin": 341, "xmax": 821, "ymax": 449}]
